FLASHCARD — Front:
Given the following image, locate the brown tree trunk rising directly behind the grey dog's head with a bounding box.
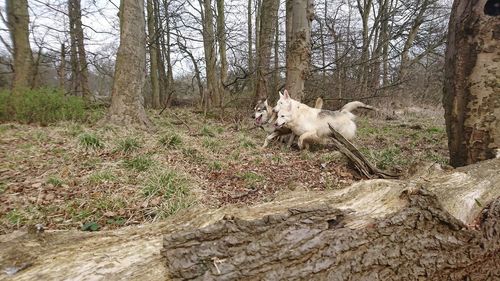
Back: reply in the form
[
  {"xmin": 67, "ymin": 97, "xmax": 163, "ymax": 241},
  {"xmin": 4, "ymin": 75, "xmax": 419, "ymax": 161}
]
[{"xmin": 254, "ymin": 0, "xmax": 280, "ymax": 101}]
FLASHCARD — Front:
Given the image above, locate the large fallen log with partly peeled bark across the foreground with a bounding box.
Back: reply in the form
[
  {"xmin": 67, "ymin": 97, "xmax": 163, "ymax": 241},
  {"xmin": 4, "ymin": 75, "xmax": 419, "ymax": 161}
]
[{"xmin": 0, "ymin": 159, "xmax": 500, "ymax": 280}]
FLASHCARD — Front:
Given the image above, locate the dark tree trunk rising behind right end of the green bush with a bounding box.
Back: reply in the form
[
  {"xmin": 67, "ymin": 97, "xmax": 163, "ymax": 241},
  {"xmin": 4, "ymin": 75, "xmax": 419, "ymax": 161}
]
[{"xmin": 68, "ymin": 0, "xmax": 91, "ymax": 100}]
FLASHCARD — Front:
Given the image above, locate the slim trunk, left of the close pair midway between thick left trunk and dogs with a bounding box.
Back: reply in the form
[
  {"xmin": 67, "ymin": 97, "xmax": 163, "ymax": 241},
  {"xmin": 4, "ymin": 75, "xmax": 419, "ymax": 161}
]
[{"xmin": 199, "ymin": 0, "xmax": 219, "ymax": 112}]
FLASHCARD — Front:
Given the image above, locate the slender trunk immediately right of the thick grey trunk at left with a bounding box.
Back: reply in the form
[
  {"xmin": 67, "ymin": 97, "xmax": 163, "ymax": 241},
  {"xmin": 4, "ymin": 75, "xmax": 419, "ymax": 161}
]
[{"xmin": 147, "ymin": 0, "xmax": 160, "ymax": 108}]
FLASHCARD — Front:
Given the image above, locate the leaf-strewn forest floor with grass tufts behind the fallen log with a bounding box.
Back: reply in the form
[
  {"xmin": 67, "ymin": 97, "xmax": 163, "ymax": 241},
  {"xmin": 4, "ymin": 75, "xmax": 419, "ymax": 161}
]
[{"xmin": 0, "ymin": 104, "xmax": 447, "ymax": 234}]
